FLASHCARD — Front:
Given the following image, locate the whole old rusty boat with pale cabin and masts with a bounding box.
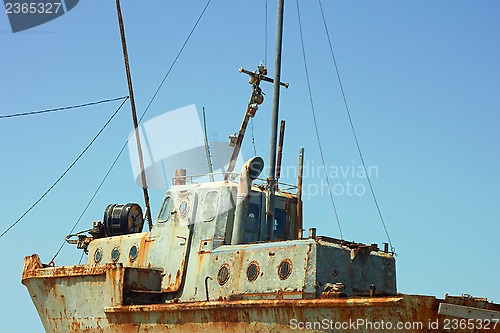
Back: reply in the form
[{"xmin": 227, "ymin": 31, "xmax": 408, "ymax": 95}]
[{"xmin": 22, "ymin": 0, "xmax": 500, "ymax": 333}]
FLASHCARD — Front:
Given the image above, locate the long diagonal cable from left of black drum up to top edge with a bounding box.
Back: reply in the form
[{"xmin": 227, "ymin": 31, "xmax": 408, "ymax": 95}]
[{"xmin": 50, "ymin": 0, "xmax": 212, "ymax": 262}]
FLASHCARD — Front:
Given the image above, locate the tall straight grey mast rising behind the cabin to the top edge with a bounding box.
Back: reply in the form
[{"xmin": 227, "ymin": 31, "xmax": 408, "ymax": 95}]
[{"xmin": 266, "ymin": 0, "xmax": 285, "ymax": 240}]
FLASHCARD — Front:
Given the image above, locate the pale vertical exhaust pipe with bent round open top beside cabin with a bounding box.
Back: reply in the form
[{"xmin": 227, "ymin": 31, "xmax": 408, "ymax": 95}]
[{"xmin": 231, "ymin": 156, "xmax": 264, "ymax": 245}]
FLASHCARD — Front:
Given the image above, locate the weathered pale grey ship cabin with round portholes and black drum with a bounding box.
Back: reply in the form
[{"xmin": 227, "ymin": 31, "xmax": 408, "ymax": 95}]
[{"xmin": 80, "ymin": 157, "xmax": 396, "ymax": 305}]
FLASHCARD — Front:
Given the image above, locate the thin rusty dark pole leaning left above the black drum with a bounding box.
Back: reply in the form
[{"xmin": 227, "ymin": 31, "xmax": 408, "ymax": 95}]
[{"xmin": 116, "ymin": 0, "xmax": 153, "ymax": 230}]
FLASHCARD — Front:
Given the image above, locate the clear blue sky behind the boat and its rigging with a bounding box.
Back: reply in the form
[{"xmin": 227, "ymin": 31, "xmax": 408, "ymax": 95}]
[{"xmin": 0, "ymin": 0, "xmax": 500, "ymax": 332}]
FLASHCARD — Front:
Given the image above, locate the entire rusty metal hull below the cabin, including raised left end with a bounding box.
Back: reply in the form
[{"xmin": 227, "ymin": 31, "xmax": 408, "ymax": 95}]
[{"xmin": 22, "ymin": 255, "xmax": 500, "ymax": 333}]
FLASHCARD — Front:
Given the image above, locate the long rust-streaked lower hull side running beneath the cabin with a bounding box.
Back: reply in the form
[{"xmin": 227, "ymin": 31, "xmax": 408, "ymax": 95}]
[{"xmin": 106, "ymin": 295, "xmax": 498, "ymax": 333}]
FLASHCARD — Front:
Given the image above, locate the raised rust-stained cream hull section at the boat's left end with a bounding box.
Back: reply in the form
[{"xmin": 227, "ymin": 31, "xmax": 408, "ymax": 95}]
[{"xmin": 22, "ymin": 255, "xmax": 124, "ymax": 332}]
